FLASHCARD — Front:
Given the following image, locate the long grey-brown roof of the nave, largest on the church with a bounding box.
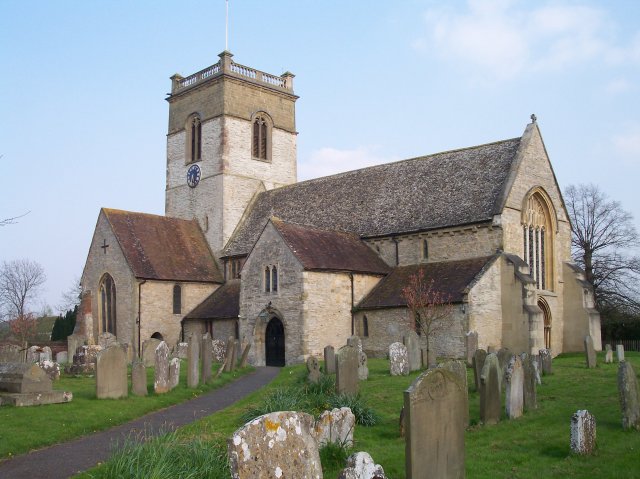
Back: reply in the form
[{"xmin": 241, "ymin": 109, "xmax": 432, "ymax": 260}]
[{"xmin": 223, "ymin": 138, "xmax": 520, "ymax": 256}]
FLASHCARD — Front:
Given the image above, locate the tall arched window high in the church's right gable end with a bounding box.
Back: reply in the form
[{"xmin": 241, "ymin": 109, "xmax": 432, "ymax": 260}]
[{"xmin": 522, "ymin": 188, "xmax": 556, "ymax": 291}]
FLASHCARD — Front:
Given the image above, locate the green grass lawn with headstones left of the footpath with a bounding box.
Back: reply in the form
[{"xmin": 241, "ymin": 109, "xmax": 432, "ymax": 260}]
[{"xmin": 0, "ymin": 360, "xmax": 253, "ymax": 460}]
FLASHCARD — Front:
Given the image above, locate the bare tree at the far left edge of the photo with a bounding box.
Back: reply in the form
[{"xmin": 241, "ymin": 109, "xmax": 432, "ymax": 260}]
[{"xmin": 0, "ymin": 259, "xmax": 47, "ymax": 320}]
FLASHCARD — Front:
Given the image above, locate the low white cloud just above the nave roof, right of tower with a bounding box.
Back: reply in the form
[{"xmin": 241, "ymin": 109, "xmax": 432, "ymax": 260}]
[{"xmin": 298, "ymin": 146, "xmax": 399, "ymax": 180}]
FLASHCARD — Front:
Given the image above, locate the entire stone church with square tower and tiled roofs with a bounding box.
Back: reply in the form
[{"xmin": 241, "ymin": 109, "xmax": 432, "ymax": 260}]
[{"xmin": 76, "ymin": 52, "xmax": 600, "ymax": 365}]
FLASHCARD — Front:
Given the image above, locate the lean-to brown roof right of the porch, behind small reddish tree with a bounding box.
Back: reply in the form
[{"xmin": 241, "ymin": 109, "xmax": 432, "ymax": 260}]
[{"xmin": 356, "ymin": 255, "xmax": 496, "ymax": 309}]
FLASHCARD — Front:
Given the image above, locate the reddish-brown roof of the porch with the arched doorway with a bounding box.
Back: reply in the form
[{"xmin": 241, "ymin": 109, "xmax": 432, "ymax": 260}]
[{"xmin": 271, "ymin": 218, "xmax": 390, "ymax": 274}]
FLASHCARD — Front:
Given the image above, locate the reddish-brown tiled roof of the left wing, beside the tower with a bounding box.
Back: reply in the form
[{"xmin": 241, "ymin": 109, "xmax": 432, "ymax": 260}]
[{"xmin": 102, "ymin": 208, "xmax": 223, "ymax": 283}]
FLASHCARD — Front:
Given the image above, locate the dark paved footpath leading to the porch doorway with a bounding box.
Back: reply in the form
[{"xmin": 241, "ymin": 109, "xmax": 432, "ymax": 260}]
[{"xmin": 0, "ymin": 367, "xmax": 280, "ymax": 479}]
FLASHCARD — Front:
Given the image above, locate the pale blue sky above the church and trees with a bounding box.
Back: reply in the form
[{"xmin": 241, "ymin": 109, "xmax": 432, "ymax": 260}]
[{"xmin": 0, "ymin": 0, "xmax": 640, "ymax": 311}]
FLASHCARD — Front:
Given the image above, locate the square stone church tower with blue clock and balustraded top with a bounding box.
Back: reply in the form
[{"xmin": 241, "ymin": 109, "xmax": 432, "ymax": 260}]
[{"xmin": 165, "ymin": 51, "xmax": 298, "ymax": 256}]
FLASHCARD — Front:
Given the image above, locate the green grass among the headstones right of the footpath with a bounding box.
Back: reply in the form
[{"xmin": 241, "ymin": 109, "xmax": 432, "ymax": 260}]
[{"xmin": 83, "ymin": 352, "xmax": 640, "ymax": 479}]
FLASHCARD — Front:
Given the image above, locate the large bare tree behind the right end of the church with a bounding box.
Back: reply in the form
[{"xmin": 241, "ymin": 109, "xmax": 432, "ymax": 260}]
[{"xmin": 565, "ymin": 184, "xmax": 640, "ymax": 313}]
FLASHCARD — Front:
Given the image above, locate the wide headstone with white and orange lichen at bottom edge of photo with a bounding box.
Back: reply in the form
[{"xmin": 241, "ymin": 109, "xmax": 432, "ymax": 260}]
[{"xmin": 228, "ymin": 411, "xmax": 322, "ymax": 479}]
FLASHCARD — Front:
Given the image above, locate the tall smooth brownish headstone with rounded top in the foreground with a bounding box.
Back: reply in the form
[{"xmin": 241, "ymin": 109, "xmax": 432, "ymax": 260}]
[{"xmin": 404, "ymin": 368, "xmax": 467, "ymax": 479}]
